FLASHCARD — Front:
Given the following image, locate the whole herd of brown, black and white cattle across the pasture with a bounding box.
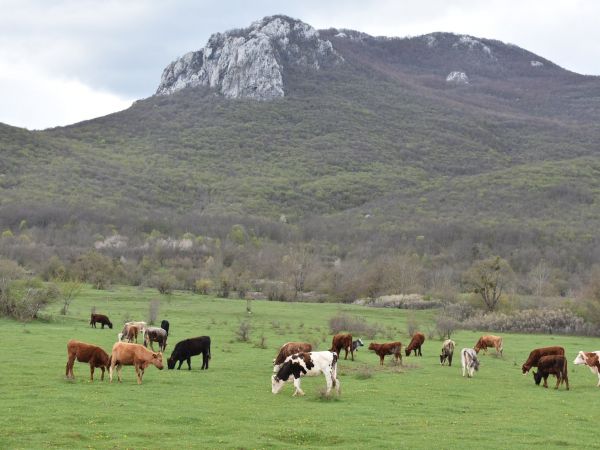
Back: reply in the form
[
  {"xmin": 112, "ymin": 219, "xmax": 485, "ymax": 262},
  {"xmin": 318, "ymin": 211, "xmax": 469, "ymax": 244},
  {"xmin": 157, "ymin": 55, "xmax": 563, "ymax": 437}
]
[{"xmin": 66, "ymin": 314, "xmax": 600, "ymax": 396}]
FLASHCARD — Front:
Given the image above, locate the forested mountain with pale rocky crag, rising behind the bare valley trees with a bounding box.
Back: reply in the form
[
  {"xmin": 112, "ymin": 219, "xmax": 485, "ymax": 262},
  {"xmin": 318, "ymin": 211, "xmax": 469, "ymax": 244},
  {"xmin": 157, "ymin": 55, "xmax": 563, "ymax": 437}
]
[{"xmin": 0, "ymin": 16, "xmax": 600, "ymax": 270}]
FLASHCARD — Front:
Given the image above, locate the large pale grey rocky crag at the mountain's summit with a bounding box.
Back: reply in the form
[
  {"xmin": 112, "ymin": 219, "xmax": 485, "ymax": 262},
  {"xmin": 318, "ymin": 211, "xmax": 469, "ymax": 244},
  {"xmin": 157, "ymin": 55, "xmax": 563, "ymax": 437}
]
[{"xmin": 156, "ymin": 15, "xmax": 343, "ymax": 100}]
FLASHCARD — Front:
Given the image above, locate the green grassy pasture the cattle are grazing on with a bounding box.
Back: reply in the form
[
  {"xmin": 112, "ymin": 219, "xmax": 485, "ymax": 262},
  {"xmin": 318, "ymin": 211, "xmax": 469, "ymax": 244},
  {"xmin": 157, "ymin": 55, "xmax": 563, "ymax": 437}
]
[{"xmin": 0, "ymin": 287, "xmax": 600, "ymax": 448}]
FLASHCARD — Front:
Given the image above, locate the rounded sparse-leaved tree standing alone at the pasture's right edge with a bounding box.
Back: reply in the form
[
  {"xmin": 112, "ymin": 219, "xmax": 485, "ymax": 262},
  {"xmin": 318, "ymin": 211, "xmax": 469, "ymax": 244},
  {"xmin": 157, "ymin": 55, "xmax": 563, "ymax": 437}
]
[{"xmin": 463, "ymin": 256, "xmax": 514, "ymax": 311}]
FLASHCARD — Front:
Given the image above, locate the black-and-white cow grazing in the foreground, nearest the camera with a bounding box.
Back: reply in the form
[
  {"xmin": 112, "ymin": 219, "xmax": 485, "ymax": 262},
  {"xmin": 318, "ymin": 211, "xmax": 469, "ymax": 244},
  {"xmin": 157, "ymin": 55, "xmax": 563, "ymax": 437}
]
[{"xmin": 271, "ymin": 351, "xmax": 340, "ymax": 396}]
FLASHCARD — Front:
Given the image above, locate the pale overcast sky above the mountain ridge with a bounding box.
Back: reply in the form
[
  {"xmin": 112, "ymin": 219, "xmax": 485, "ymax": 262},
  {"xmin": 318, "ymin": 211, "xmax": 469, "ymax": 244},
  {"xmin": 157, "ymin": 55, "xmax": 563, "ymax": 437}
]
[{"xmin": 0, "ymin": 0, "xmax": 600, "ymax": 129}]
